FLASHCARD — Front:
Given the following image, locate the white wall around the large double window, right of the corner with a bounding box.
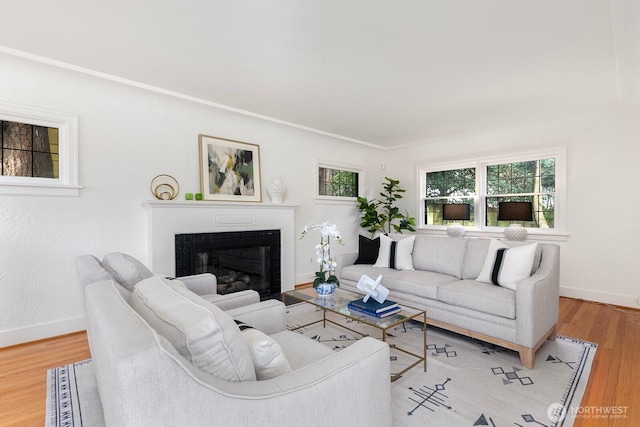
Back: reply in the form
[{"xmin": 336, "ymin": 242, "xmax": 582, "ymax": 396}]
[{"xmin": 386, "ymin": 106, "xmax": 640, "ymax": 308}]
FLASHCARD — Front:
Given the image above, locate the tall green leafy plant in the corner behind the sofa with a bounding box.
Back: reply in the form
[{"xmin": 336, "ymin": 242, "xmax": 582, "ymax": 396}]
[{"xmin": 358, "ymin": 176, "xmax": 416, "ymax": 235}]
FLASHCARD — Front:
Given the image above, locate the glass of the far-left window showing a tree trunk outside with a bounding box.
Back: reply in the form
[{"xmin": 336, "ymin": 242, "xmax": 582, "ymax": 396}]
[{"xmin": 0, "ymin": 121, "xmax": 59, "ymax": 179}]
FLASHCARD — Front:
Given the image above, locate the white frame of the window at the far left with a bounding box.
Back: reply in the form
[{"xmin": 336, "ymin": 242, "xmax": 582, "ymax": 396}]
[{"xmin": 0, "ymin": 102, "xmax": 82, "ymax": 196}]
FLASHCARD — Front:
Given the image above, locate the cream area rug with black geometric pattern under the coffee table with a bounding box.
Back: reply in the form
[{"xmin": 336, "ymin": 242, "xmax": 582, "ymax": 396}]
[{"xmin": 46, "ymin": 303, "xmax": 597, "ymax": 427}]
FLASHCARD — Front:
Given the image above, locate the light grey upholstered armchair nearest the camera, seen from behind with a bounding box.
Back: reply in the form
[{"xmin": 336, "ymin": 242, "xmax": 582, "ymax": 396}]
[{"xmin": 76, "ymin": 256, "xmax": 391, "ymax": 427}]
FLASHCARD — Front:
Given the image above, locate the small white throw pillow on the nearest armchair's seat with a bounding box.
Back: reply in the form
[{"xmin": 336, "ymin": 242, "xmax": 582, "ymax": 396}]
[{"xmin": 236, "ymin": 320, "xmax": 291, "ymax": 381}]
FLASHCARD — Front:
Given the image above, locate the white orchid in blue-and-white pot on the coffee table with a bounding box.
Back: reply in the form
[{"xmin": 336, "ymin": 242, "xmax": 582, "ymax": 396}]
[{"xmin": 300, "ymin": 221, "xmax": 343, "ymax": 296}]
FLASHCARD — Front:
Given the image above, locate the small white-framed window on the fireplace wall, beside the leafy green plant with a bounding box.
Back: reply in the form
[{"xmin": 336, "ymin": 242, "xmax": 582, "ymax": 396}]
[{"xmin": 317, "ymin": 163, "xmax": 363, "ymax": 201}]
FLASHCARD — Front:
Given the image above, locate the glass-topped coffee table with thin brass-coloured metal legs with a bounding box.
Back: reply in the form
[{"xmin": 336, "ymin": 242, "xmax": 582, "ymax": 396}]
[{"xmin": 282, "ymin": 287, "xmax": 427, "ymax": 382}]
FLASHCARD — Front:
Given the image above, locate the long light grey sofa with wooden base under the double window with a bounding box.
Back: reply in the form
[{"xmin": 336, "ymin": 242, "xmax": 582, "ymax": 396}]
[{"xmin": 336, "ymin": 234, "xmax": 560, "ymax": 368}]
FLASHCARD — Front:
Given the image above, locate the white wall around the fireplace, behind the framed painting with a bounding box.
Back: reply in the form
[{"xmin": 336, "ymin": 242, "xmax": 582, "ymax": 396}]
[{"xmin": 0, "ymin": 55, "xmax": 379, "ymax": 347}]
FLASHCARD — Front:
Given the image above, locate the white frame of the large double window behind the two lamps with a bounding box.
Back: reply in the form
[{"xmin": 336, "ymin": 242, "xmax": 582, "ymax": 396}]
[{"xmin": 416, "ymin": 146, "xmax": 568, "ymax": 238}]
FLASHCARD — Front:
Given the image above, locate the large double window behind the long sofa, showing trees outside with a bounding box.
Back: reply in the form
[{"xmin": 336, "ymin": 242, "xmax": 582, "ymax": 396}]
[{"xmin": 419, "ymin": 148, "xmax": 566, "ymax": 234}]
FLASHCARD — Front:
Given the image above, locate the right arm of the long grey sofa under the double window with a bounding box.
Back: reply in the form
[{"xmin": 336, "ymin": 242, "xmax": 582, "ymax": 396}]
[{"xmin": 516, "ymin": 244, "xmax": 560, "ymax": 348}]
